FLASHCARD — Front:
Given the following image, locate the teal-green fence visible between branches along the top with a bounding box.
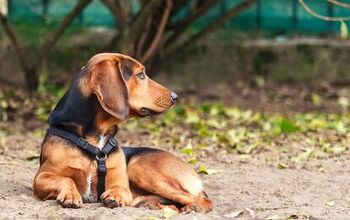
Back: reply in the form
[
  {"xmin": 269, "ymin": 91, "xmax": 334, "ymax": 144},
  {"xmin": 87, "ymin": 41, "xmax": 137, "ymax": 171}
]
[{"xmin": 9, "ymin": 0, "xmax": 350, "ymax": 34}]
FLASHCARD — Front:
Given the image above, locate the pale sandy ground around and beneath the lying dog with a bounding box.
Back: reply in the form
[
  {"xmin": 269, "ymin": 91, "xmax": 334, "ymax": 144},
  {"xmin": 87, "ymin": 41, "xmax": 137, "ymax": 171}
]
[{"xmin": 0, "ymin": 131, "xmax": 350, "ymax": 219}]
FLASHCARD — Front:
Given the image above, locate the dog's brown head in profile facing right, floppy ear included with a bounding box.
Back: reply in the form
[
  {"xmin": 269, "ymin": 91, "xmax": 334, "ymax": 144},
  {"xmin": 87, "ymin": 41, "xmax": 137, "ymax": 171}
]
[{"xmin": 79, "ymin": 53, "xmax": 177, "ymax": 120}]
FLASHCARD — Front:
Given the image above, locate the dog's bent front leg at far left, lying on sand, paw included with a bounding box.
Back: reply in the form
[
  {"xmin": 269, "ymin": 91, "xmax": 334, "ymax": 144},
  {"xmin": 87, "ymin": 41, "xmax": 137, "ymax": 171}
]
[{"xmin": 33, "ymin": 172, "xmax": 83, "ymax": 208}]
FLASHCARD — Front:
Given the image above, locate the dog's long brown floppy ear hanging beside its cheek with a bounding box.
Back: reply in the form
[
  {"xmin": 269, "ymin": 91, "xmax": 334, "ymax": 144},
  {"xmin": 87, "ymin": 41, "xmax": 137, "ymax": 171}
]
[{"xmin": 90, "ymin": 60, "xmax": 129, "ymax": 120}]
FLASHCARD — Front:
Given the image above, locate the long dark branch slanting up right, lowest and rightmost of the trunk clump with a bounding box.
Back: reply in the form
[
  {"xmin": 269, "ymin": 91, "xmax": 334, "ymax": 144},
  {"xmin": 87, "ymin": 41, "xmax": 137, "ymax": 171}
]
[{"xmin": 165, "ymin": 0, "xmax": 256, "ymax": 57}]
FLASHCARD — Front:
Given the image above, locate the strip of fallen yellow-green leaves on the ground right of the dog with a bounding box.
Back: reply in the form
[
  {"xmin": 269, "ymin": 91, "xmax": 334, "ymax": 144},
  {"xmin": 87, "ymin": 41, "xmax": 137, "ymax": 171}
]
[{"xmin": 122, "ymin": 102, "xmax": 350, "ymax": 163}]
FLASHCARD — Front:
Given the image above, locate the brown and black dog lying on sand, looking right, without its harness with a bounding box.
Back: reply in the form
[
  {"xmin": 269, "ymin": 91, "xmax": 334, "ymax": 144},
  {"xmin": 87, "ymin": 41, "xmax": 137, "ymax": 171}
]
[{"xmin": 33, "ymin": 53, "xmax": 212, "ymax": 212}]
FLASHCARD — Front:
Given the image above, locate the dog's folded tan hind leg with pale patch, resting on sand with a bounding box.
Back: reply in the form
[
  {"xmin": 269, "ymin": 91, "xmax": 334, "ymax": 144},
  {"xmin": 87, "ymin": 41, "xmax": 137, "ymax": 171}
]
[{"xmin": 128, "ymin": 151, "xmax": 213, "ymax": 212}]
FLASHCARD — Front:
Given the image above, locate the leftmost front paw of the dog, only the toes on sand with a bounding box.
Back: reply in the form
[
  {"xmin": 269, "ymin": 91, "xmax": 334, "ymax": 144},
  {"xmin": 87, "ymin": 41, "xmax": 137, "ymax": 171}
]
[{"xmin": 56, "ymin": 190, "xmax": 83, "ymax": 208}]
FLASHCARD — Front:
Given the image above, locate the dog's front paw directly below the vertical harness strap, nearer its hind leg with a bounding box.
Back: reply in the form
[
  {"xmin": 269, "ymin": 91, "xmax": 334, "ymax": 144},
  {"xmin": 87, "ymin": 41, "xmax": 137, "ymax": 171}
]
[{"xmin": 101, "ymin": 187, "xmax": 132, "ymax": 208}]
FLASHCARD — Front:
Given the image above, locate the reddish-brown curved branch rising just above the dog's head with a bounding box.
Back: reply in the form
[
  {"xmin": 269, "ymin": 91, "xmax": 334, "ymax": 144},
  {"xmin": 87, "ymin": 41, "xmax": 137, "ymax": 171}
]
[{"xmin": 140, "ymin": 0, "xmax": 173, "ymax": 63}]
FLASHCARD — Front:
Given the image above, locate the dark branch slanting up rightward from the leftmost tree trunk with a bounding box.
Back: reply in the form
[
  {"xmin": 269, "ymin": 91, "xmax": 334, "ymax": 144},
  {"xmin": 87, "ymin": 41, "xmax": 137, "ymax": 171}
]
[{"xmin": 35, "ymin": 0, "xmax": 92, "ymax": 66}]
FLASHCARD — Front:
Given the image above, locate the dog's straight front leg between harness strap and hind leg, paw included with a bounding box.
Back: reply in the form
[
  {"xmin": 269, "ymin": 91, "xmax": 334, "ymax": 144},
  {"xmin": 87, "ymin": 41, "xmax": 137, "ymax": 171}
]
[{"xmin": 101, "ymin": 151, "xmax": 132, "ymax": 208}]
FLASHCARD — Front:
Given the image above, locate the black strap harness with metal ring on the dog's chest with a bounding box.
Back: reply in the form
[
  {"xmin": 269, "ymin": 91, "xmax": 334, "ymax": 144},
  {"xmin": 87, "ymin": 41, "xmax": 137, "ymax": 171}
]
[{"xmin": 48, "ymin": 127, "xmax": 118, "ymax": 200}]
